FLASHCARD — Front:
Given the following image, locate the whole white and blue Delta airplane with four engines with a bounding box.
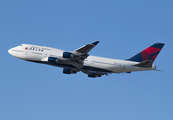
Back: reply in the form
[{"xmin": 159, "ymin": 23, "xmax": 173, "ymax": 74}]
[{"xmin": 8, "ymin": 41, "xmax": 164, "ymax": 78}]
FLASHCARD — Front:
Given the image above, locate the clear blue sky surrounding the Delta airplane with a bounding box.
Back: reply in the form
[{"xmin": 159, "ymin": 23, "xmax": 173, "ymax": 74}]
[{"xmin": 0, "ymin": 0, "xmax": 173, "ymax": 120}]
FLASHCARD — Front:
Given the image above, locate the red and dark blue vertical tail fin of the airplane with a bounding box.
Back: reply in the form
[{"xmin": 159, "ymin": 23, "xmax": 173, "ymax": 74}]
[{"xmin": 128, "ymin": 43, "xmax": 165, "ymax": 62}]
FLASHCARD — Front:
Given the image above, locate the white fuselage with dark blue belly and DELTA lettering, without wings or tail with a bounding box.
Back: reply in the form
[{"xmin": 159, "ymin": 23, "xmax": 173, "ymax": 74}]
[{"xmin": 8, "ymin": 44, "xmax": 156, "ymax": 73}]
